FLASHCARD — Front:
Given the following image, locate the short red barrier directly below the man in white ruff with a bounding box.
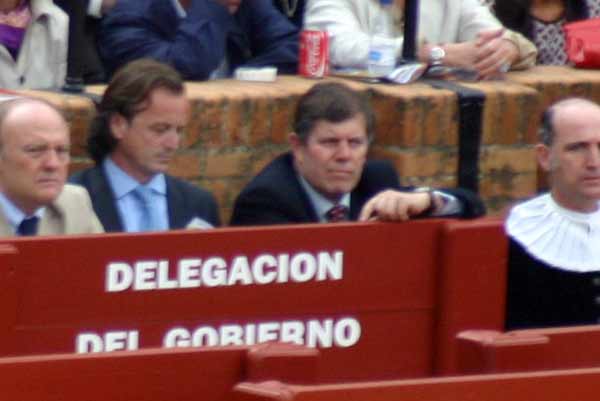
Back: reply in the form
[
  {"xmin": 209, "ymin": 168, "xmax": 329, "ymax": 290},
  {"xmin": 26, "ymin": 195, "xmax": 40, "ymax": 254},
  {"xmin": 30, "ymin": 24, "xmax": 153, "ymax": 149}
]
[{"xmin": 457, "ymin": 326, "xmax": 600, "ymax": 373}]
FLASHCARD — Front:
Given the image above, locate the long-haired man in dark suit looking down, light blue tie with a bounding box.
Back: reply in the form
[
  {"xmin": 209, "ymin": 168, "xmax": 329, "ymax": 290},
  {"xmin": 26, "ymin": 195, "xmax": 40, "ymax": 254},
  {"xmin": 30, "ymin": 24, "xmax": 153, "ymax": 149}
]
[{"xmin": 71, "ymin": 59, "xmax": 219, "ymax": 232}]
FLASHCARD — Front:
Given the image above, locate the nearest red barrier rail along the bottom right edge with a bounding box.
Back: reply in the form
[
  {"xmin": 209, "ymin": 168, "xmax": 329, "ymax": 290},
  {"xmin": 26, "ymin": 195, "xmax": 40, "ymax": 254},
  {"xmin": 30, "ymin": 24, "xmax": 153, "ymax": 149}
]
[{"xmin": 231, "ymin": 368, "xmax": 600, "ymax": 401}]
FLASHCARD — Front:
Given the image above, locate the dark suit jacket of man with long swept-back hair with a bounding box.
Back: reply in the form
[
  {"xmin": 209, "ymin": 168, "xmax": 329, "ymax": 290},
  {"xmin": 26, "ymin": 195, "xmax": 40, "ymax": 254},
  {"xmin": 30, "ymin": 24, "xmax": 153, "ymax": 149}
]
[{"xmin": 69, "ymin": 166, "xmax": 220, "ymax": 232}]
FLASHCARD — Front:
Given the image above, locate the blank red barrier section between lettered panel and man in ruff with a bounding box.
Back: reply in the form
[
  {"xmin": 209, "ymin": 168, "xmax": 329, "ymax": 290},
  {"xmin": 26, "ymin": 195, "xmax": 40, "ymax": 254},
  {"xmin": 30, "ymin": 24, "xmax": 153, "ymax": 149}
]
[{"xmin": 434, "ymin": 219, "xmax": 508, "ymax": 374}]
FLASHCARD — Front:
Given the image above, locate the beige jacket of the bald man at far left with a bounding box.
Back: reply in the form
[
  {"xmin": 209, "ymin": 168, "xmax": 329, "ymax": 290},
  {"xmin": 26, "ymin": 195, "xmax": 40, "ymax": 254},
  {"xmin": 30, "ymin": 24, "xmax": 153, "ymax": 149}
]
[{"xmin": 0, "ymin": 184, "xmax": 104, "ymax": 237}]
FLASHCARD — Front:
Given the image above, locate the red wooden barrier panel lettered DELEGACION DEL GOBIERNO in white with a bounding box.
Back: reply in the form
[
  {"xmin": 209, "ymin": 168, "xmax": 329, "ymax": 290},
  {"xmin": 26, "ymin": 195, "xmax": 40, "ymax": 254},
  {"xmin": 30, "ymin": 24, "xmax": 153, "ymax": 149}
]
[{"xmin": 0, "ymin": 221, "xmax": 440, "ymax": 379}]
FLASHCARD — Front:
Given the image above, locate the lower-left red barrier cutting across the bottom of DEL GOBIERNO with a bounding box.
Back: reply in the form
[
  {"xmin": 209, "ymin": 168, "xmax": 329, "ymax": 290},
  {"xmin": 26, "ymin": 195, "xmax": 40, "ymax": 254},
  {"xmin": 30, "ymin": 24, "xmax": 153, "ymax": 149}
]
[{"xmin": 0, "ymin": 344, "xmax": 318, "ymax": 401}]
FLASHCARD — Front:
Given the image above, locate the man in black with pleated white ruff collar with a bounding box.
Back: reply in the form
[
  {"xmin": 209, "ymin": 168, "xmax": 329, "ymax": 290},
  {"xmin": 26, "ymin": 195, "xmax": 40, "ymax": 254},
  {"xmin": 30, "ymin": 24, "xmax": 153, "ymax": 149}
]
[{"xmin": 506, "ymin": 98, "xmax": 600, "ymax": 329}]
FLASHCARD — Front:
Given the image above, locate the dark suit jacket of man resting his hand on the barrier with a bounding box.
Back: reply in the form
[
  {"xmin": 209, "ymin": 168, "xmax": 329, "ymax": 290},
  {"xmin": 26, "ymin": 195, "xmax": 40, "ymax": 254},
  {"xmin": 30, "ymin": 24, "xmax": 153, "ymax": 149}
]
[{"xmin": 231, "ymin": 153, "xmax": 485, "ymax": 225}]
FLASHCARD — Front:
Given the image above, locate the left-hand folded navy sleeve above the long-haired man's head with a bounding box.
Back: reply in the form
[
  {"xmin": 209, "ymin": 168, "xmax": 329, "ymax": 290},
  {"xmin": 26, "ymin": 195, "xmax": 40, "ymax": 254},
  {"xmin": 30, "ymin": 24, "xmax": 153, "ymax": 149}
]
[{"xmin": 100, "ymin": 0, "xmax": 232, "ymax": 80}]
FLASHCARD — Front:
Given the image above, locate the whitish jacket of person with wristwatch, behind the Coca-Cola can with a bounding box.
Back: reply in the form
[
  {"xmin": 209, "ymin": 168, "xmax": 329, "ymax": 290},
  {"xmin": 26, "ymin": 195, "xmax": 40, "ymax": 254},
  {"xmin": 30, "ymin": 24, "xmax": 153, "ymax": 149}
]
[{"xmin": 304, "ymin": 0, "xmax": 537, "ymax": 68}]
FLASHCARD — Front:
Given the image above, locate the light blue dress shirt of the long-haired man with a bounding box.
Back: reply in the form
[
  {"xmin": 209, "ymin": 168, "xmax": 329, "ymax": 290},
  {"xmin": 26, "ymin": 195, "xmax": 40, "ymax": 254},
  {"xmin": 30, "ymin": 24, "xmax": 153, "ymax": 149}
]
[{"xmin": 102, "ymin": 157, "xmax": 169, "ymax": 232}]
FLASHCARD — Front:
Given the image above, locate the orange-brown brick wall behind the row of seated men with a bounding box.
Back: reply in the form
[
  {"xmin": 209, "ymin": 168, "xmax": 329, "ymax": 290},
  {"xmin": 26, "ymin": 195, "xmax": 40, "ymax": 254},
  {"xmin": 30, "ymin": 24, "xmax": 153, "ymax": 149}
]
[{"xmin": 22, "ymin": 67, "xmax": 600, "ymax": 222}]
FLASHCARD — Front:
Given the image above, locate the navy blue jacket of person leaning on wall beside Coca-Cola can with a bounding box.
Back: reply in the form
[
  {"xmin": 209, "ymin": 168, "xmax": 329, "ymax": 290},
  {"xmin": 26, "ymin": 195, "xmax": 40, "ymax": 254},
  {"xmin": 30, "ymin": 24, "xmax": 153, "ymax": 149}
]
[{"xmin": 99, "ymin": 0, "xmax": 298, "ymax": 80}]
